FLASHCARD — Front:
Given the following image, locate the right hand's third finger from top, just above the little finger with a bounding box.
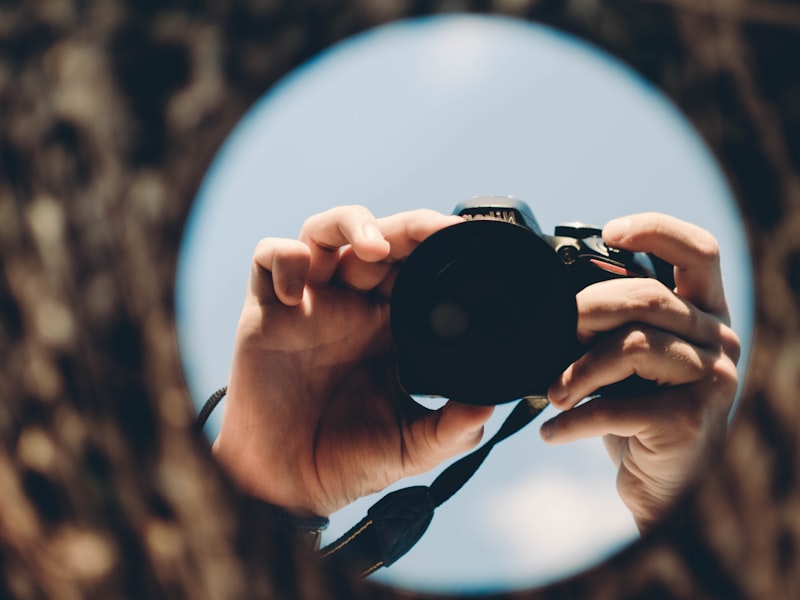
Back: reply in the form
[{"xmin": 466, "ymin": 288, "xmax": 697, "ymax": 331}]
[{"xmin": 548, "ymin": 325, "xmax": 735, "ymax": 408}]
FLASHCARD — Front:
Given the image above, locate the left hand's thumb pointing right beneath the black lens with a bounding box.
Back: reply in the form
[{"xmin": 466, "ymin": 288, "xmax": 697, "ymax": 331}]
[{"xmin": 407, "ymin": 401, "xmax": 494, "ymax": 472}]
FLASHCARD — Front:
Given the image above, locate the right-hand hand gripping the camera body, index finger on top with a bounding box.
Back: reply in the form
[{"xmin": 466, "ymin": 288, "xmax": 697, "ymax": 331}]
[{"xmin": 541, "ymin": 213, "xmax": 740, "ymax": 530}]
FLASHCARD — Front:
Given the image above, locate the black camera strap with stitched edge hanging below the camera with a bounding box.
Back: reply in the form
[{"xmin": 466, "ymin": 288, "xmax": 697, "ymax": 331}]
[{"xmin": 195, "ymin": 388, "xmax": 548, "ymax": 577}]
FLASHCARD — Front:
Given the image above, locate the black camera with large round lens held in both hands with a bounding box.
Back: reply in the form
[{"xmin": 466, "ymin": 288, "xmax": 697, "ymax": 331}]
[{"xmin": 391, "ymin": 197, "xmax": 674, "ymax": 405}]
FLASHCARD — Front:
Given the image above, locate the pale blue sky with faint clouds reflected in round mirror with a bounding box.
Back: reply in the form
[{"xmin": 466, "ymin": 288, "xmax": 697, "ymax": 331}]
[{"xmin": 176, "ymin": 15, "xmax": 753, "ymax": 592}]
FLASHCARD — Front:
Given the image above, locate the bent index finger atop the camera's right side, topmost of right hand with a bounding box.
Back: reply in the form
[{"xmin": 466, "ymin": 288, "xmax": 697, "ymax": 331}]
[{"xmin": 603, "ymin": 213, "xmax": 730, "ymax": 322}]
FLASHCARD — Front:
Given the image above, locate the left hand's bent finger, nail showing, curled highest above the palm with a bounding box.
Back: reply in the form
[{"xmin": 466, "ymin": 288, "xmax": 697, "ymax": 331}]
[{"xmin": 299, "ymin": 206, "xmax": 390, "ymax": 284}]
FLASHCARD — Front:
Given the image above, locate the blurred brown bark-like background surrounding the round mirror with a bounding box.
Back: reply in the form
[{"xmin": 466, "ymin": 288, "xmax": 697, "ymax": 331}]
[{"xmin": 0, "ymin": 0, "xmax": 800, "ymax": 600}]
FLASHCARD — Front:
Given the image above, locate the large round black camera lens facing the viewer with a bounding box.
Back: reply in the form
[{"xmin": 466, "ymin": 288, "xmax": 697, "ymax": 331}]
[{"xmin": 391, "ymin": 220, "xmax": 577, "ymax": 404}]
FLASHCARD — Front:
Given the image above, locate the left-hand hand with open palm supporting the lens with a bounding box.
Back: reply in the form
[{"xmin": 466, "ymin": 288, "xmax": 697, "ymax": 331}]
[{"xmin": 214, "ymin": 206, "xmax": 492, "ymax": 516}]
